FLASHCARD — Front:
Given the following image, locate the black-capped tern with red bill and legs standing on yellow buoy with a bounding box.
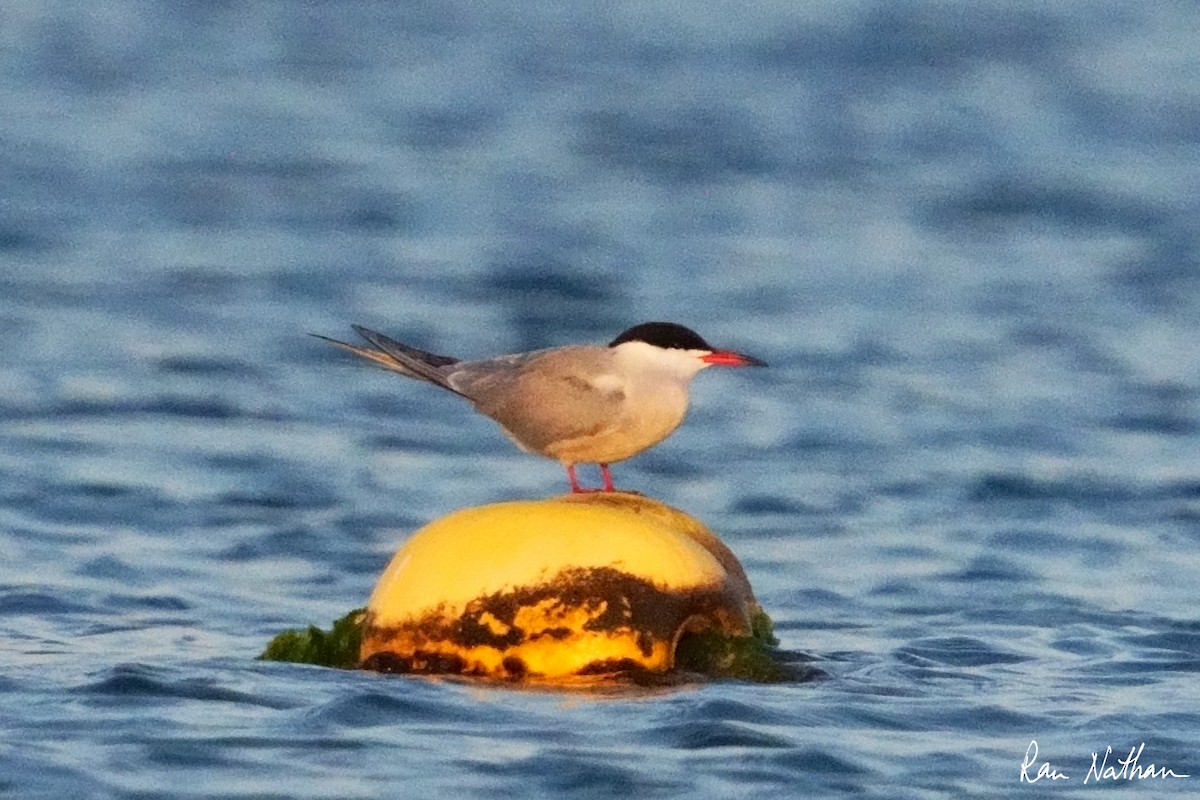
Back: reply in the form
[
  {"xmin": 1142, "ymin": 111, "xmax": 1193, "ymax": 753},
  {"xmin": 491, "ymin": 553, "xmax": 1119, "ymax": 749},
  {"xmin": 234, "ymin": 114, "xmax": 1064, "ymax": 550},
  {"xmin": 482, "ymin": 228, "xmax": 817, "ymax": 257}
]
[{"xmin": 313, "ymin": 323, "xmax": 767, "ymax": 492}]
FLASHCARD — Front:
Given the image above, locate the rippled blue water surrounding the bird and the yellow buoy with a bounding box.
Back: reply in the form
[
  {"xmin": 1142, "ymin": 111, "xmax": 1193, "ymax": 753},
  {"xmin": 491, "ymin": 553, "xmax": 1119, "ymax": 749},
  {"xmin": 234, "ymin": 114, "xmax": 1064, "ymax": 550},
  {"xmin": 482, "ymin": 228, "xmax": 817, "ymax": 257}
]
[{"xmin": 0, "ymin": 0, "xmax": 1200, "ymax": 799}]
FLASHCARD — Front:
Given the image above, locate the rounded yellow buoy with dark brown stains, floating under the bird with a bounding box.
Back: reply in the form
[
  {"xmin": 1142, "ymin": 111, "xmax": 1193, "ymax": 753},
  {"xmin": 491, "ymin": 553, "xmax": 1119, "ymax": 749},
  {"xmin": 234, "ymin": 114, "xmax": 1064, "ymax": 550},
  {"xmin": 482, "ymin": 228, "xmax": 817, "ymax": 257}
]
[{"xmin": 359, "ymin": 492, "xmax": 769, "ymax": 682}]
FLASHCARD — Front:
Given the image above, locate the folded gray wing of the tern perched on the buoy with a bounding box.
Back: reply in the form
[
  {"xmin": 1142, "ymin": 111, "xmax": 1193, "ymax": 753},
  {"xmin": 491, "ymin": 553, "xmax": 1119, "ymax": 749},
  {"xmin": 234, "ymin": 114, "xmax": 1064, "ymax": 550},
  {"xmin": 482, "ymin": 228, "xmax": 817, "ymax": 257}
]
[{"xmin": 449, "ymin": 347, "xmax": 625, "ymax": 452}]
